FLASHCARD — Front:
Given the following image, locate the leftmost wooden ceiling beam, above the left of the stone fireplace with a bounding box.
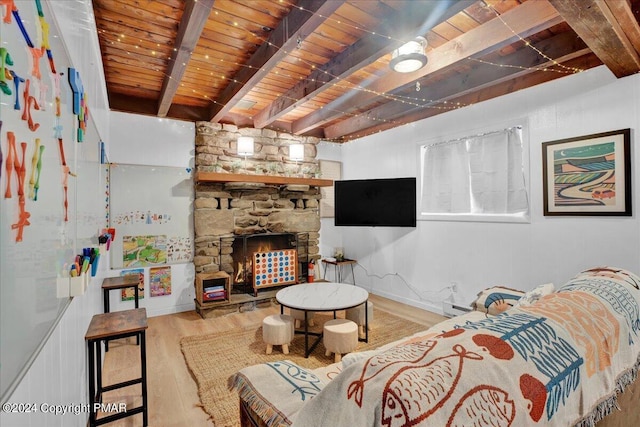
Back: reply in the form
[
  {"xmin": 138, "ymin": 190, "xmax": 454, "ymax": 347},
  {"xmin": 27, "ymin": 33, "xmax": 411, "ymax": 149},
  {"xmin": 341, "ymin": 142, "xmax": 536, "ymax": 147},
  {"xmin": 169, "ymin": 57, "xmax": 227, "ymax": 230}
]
[{"xmin": 157, "ymin": 0, "xmax": 214, "ymax": 117}]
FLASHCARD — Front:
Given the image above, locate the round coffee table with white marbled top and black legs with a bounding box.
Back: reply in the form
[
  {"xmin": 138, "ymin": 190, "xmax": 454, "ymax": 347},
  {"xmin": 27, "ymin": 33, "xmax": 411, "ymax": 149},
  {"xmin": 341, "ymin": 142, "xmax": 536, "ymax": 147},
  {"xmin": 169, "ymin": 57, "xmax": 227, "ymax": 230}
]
[{"xmin": 276, "ymin": 282, "xmax": 369, "ymax": 357}]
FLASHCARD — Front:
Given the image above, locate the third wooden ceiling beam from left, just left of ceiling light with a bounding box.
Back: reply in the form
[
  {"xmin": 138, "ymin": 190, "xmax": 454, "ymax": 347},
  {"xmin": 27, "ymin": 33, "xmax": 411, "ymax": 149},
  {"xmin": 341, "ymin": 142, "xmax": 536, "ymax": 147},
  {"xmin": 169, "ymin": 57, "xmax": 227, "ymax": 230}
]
[{"xmin": 253, "ymin": 0, "xmax": 475, "ymax": 128}]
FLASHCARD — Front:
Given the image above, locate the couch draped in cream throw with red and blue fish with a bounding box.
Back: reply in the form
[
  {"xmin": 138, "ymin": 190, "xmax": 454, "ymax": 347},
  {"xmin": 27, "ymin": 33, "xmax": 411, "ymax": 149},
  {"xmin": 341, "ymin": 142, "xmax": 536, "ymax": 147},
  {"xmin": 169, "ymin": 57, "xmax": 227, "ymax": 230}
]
[{"xmin": 230, "ymin": 267, "xmax": 640, "ymax": 427}]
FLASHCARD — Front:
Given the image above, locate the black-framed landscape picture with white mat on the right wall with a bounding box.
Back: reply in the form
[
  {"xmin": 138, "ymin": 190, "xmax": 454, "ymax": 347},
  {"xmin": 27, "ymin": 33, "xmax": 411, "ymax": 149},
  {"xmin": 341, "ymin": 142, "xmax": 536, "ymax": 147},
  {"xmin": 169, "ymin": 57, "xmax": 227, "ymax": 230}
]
[{"xmin": 542, "ymin": 129, "xmax": 632, "ymax": 216}]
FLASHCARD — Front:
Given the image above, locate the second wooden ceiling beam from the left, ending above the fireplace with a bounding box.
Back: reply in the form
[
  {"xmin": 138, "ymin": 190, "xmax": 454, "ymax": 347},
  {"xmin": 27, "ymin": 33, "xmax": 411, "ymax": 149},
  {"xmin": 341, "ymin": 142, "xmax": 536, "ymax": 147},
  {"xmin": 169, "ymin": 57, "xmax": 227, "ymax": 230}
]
[{"xmin": 209, "ymin": 0, "xmax": 345, "ymax": 122}]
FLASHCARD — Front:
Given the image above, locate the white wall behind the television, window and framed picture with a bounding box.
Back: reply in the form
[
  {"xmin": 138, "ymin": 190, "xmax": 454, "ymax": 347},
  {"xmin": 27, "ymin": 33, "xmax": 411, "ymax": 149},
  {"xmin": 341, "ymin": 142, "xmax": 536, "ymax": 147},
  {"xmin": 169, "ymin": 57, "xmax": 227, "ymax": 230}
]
[{"xmin": 319, "ymin": 67, "xmax": 640, "ymax": 310}]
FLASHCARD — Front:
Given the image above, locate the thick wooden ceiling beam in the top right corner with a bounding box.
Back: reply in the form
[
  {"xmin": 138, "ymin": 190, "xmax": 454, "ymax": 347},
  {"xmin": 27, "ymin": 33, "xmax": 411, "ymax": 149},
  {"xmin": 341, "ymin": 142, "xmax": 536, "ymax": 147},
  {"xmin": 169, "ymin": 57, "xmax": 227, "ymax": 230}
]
[{"xmin": 549, "ymin": 0, "xmax": 640, "ymax": 78}]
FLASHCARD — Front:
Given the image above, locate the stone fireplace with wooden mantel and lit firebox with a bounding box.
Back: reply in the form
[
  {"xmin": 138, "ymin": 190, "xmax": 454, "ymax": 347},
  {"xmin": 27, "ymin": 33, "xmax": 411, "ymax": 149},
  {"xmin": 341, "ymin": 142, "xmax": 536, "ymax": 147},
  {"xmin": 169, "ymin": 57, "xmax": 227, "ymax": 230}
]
[{"xmin": 194, "ymin": 122, "xmax": 326, "ymax": 300}]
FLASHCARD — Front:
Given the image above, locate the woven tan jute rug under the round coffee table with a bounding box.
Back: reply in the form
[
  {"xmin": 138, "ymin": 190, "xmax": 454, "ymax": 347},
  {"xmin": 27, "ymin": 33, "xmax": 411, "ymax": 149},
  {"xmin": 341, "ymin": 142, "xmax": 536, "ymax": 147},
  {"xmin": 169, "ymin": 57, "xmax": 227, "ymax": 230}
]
[{"xmin": 180, "ymin": 308, "xmax": 427, "ymax": 427}]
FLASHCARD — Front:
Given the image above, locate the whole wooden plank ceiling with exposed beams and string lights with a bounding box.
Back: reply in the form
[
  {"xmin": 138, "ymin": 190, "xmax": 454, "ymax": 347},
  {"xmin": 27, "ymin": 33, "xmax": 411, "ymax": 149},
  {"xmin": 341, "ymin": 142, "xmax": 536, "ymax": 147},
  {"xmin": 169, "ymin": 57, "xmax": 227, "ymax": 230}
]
[{"xmin": 93, "ymin": 0, "xmax": 640, "ymax": 142}]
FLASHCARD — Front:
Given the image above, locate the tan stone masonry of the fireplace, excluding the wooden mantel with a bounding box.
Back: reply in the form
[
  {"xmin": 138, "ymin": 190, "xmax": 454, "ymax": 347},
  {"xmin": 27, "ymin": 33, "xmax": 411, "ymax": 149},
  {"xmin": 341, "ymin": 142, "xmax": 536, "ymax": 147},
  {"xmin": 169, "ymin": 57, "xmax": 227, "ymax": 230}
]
[{"xmin": 194, "ymin": 122, "xmax": 321, "ymax": 286}]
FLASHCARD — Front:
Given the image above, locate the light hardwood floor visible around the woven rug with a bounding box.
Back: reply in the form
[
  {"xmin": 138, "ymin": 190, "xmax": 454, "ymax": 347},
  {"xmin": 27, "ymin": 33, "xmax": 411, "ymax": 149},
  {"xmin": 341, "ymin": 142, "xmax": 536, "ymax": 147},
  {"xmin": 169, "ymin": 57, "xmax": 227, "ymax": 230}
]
[{"xmin": 96, "ymin": 295, "xmax": 444, "ymax": 427}]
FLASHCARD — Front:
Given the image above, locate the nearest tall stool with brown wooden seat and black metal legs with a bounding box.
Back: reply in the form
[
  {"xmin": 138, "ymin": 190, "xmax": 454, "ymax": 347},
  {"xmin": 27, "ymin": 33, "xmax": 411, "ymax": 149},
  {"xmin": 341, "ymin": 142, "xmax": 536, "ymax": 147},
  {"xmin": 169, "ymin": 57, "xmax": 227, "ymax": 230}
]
[{"xmin": 84, "ymin": 308, "xmax": 149, "ymax": 427}]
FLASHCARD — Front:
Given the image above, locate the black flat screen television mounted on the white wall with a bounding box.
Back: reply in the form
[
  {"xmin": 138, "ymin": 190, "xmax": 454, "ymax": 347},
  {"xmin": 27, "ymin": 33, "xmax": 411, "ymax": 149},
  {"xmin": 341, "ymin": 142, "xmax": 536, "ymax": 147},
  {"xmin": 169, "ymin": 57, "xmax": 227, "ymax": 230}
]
[{"xmin": 334, "ymin": 178, "xmax": 416, "ymax": 227}]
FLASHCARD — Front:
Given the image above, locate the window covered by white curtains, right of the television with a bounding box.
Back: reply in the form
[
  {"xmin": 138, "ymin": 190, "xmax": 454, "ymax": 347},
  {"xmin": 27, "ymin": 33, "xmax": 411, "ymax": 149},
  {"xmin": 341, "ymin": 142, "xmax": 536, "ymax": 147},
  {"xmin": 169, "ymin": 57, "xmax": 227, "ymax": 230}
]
[{"xmin": 420, "ymin": 126, "xmax": 529, "ymax": 222}]
